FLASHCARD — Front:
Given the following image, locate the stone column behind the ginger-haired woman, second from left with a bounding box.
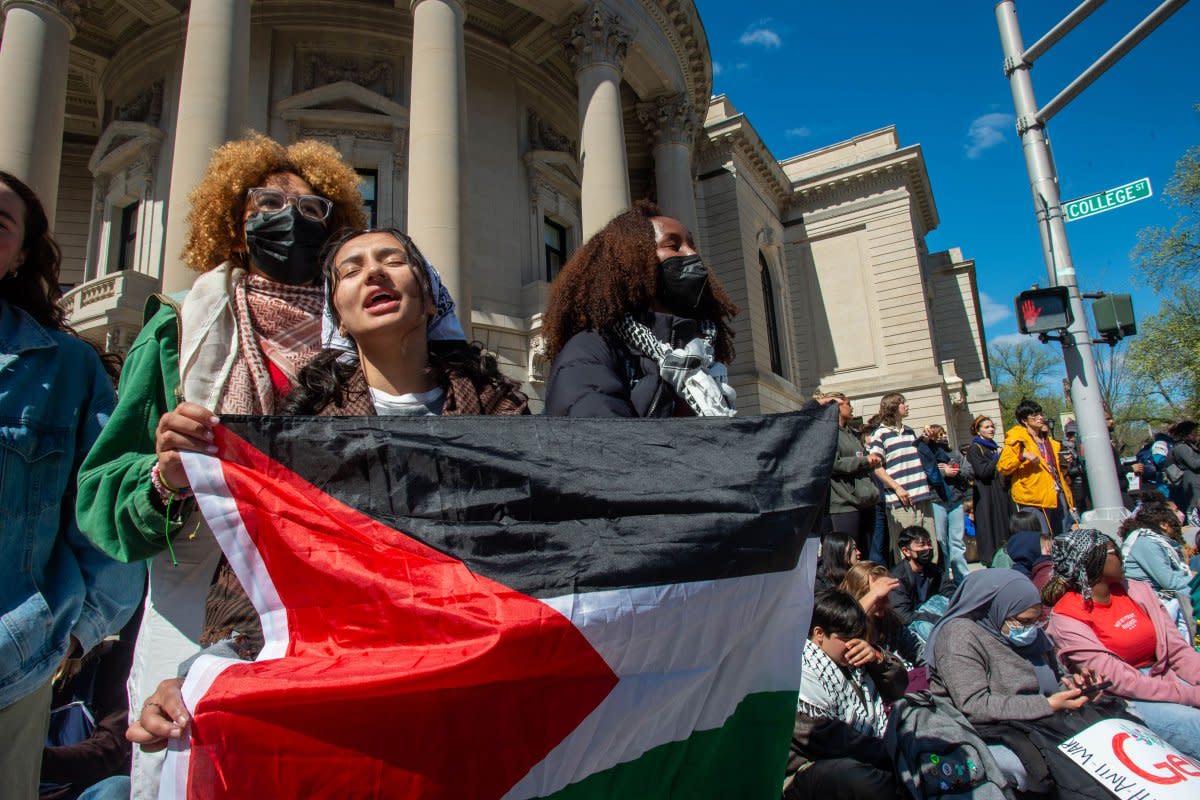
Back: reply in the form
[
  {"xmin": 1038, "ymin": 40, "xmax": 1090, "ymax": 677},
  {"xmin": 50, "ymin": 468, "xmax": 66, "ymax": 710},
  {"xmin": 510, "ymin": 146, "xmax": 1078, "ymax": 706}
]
[{"xmin": 162, "ymin": 0, "xmax": 251, "ymax": 293}]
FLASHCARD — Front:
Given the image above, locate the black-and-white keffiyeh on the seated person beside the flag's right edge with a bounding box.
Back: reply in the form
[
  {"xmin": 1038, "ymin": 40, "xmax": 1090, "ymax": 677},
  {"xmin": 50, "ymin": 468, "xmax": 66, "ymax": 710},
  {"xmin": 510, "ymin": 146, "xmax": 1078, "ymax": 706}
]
[{"xmin": 796, "ymin": 640, "xmax": 888, "ymax": 739}]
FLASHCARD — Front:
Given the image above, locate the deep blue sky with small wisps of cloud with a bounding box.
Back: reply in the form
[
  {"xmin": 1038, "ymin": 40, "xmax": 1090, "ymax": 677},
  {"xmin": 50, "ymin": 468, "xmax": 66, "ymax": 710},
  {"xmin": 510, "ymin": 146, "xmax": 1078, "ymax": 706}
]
[{"xmin": 696, "ymin": 0, "xmax": 1200, "ymax": 357}]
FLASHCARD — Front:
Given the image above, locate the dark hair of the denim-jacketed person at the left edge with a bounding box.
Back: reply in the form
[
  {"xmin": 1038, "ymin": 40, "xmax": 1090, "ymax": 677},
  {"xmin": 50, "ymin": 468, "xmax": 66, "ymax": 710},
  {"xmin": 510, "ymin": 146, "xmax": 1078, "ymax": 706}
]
[{"xmin": 0, "ymin": 170, "xmax": 72, "ymax": 333}]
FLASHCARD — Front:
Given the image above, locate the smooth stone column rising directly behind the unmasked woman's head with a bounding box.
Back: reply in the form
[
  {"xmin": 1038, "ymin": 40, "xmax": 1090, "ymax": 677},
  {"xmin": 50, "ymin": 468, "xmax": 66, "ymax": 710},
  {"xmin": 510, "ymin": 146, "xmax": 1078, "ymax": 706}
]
[{"xmin": 408, "ymin": 0, "xmax": 472, "ymax": 339}]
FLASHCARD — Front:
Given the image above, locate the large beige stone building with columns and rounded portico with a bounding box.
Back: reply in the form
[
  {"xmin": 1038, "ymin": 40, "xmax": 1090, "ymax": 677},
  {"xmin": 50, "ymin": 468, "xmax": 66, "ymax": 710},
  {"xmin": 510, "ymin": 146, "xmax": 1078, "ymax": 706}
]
[{"xmin": 0, "ymin": 0, "xmax": 1000, "ymax": 439}]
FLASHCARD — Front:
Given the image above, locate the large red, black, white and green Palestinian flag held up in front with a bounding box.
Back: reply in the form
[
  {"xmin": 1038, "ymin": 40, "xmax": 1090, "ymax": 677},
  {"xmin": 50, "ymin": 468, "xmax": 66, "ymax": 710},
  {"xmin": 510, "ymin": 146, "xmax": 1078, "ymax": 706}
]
[{"xmin": 161, "ymin": 408, "xmax": 836, "ymax": 800}]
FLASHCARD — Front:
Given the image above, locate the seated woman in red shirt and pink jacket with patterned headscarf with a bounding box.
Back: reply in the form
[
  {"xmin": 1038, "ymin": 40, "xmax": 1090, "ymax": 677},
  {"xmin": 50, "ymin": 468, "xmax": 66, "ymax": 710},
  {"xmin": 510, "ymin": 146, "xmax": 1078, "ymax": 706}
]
[{"xmin": 1042, "ymin": 529, "xmax": 1200, "ymax": 758}]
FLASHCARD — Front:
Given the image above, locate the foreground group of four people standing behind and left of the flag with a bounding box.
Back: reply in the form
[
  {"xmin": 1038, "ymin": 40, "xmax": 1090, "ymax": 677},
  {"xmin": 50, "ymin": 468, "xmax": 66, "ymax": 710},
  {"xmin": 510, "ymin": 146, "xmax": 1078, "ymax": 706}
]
[{"xmin": 0, "ymin": 134, "xmax": 737, "ymax": 800}]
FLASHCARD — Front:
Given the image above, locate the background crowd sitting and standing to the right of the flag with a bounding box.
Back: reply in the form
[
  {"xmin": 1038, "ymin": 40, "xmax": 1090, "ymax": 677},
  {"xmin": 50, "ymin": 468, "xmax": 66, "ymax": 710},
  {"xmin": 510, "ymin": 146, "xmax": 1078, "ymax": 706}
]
[{"xmin": 801, "ymin": 393, "xmax": 1200, "ymax": 799}]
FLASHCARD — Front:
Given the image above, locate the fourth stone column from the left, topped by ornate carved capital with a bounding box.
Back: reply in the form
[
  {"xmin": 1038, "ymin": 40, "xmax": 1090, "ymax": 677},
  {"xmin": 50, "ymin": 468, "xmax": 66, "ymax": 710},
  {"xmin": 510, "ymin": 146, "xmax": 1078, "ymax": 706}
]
[{"xmin": 566, "ymin": 2, "xmax": 634, "ymax": 240}]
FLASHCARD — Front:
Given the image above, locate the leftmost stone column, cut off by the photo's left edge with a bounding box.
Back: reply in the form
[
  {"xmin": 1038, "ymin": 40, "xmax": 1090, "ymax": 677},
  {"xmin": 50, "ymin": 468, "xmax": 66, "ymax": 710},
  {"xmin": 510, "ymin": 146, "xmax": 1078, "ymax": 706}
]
[{"xmin": 0, "ymin": 0, "xmax": 79, "ymax": 228}]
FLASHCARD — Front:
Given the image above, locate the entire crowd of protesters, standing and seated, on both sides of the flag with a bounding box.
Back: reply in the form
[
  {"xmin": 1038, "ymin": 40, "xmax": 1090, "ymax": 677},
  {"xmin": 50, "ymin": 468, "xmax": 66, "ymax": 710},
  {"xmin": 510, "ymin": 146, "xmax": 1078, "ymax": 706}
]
[{"xmin": 0, "ymin": 134, "xmax": 1200, "ymax": 800}]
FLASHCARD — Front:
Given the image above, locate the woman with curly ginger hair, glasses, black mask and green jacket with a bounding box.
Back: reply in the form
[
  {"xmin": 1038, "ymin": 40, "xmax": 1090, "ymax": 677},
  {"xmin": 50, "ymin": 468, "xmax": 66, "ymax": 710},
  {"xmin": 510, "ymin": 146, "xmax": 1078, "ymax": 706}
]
[{"xmin": 77, "ymin": 134, "xmax": 362, "ymax": 798}]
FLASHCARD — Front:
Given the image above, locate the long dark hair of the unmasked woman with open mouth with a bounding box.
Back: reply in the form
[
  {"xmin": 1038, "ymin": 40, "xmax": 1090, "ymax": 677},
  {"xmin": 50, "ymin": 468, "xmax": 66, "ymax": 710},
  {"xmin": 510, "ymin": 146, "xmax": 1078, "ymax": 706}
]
[{"xmin": 282, "ymin": 228, "xmax": 524, "ymax": 415}]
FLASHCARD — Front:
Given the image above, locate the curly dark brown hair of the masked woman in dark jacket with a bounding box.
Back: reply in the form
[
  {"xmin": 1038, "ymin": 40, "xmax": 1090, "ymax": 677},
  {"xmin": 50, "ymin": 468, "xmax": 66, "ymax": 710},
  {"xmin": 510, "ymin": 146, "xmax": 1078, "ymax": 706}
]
[{"xmin": 541, "ymin": 200, "xmax": 738, "ymax": 363}]
